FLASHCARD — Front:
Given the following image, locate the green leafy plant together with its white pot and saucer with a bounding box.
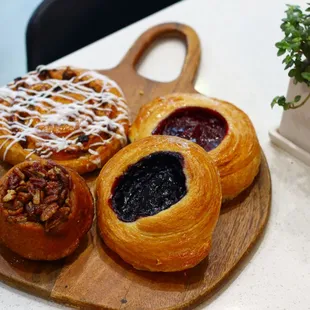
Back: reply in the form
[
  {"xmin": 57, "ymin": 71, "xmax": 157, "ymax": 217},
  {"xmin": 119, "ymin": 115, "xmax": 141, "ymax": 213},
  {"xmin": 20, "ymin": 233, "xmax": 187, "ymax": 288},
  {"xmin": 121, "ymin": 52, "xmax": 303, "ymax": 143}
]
[{"xmin": 270, "ymin": 4, "xmax": 310, "ymax": 164}]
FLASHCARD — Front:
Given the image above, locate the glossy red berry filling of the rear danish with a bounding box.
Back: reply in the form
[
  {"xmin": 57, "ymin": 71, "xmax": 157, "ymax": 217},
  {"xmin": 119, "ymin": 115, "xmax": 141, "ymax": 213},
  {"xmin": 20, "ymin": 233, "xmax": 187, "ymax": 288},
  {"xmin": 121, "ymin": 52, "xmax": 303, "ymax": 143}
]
[{"xmin": 152, "ymin": 107, "xmax": 228, "ymax": 152}]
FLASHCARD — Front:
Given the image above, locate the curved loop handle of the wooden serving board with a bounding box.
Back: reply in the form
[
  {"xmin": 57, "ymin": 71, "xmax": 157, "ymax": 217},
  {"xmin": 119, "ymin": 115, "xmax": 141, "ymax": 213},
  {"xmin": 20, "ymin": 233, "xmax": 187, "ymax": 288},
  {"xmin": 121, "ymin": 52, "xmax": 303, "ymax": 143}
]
[{"xmin": 119, "ymin": 23, "xmax": 200, "ymax": 84}]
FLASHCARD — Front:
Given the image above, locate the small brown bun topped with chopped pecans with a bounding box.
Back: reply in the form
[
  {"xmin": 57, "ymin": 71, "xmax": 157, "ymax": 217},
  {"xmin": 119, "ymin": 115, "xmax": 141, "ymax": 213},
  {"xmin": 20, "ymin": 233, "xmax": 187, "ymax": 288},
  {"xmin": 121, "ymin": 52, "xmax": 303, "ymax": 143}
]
[{"xmin": 0, "ymin": 160, "xmax": 94, "ymax": 260}]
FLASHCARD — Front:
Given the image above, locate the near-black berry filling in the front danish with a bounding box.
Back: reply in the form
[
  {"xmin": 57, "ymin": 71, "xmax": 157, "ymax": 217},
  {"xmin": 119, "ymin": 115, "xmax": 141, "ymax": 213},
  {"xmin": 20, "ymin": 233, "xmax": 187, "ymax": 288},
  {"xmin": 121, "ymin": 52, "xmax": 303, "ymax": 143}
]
[{"xmin": 110, "ymin": 152, "xmax": 187, "ymax": 222}]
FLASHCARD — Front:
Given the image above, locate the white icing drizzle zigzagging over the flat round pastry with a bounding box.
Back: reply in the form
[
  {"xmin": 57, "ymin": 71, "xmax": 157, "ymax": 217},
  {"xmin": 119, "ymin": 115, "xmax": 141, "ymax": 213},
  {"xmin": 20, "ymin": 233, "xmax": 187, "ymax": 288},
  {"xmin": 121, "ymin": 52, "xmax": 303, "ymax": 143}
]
[{"xmin": 0, "ymin": 66, "xmax": 128, "ymax": 161}]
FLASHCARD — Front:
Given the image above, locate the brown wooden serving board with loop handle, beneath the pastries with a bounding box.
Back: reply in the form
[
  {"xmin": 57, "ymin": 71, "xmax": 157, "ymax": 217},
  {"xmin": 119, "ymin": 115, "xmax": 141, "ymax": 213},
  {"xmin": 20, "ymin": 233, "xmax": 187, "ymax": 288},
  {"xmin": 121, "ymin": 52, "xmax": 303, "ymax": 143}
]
[{"xmin": 0, "ymin": 23, "xmax": 271, "ymax": 310}]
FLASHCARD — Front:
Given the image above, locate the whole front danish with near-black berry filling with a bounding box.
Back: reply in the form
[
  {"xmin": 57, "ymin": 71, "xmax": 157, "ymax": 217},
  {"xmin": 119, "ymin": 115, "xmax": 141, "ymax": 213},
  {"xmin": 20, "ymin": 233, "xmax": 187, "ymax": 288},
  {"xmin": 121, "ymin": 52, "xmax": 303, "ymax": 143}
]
[{"xmin": 97, "ymin": 136, "xmax": 222, "ymax": 272}]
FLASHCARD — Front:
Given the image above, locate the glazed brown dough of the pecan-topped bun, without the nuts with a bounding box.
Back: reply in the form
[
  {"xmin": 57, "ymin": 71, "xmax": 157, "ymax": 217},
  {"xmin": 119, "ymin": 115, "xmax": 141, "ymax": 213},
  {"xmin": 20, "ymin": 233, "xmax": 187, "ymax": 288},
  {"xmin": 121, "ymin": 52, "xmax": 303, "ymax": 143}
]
[{"xmin": 0, "ymin": 160, "xmax": 94, "ymax": 260}]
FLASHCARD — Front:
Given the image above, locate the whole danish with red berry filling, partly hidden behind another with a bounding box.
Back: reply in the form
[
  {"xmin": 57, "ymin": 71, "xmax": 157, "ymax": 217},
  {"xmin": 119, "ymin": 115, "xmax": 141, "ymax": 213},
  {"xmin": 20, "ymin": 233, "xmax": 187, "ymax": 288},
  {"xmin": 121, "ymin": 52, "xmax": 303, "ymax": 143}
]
[{"xmin": 129, "ymin": 94, "xmax": 261, "ymax": 200}]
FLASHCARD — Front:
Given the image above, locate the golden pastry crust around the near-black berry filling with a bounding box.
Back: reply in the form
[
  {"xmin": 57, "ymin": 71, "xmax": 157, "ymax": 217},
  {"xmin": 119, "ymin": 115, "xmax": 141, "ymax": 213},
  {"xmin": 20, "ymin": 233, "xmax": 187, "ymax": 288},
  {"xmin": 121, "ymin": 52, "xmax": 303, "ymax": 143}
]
[{"xmin": 97, "ymin": 136, "xmax": 222, "ymax": 272}]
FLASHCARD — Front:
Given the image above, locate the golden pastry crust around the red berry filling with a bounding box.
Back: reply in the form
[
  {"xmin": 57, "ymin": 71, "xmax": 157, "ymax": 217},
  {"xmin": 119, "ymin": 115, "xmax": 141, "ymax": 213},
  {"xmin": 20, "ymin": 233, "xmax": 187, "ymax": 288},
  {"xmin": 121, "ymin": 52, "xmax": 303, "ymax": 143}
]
[{"xmin": 129, "ymin": 93, "xmax": 261, "ymax": 200}]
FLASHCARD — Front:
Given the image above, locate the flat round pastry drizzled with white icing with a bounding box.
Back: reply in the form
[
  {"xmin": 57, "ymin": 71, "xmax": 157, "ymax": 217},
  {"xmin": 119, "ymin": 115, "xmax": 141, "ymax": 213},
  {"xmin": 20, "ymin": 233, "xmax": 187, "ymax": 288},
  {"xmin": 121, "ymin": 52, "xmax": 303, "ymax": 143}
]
[{"xmin": 0, "ymin": 66, "xmax": 129, "ymax": 174}]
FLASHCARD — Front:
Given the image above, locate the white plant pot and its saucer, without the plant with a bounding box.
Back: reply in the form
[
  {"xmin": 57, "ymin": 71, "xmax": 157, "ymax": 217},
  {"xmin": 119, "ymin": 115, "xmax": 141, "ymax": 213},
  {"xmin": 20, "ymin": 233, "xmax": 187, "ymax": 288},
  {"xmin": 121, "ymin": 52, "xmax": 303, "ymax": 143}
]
[{"xmin": 269, "ymin": 79, "xmax": 310, "ymax": 165}]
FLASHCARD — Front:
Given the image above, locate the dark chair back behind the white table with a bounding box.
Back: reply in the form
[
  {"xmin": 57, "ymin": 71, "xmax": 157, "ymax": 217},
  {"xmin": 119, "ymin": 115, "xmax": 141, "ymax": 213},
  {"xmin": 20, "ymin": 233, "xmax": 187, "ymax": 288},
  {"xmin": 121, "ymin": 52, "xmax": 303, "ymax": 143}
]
[{"xmin": 26, "ymin": 0, "xmax": 180, "ymax": 71}]
